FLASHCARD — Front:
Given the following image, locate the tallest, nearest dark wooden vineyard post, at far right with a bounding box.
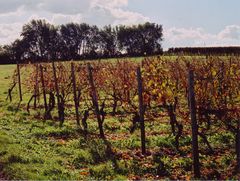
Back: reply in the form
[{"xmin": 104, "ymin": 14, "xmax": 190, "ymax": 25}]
[{"xmin": 188, "ymin": 70, "xmax": 200, "ymax": 178}]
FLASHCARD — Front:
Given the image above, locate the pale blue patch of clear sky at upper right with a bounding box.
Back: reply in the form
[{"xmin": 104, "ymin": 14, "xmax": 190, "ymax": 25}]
[{"xmin": 129, "ymin": 0, "xmax": 240, "ymax": 33}]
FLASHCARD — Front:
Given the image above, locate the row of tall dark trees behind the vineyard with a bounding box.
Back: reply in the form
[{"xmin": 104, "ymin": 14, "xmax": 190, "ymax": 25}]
[{"xmin": 0, "ymin": 20, "xmax": 163, "ymax": 63}]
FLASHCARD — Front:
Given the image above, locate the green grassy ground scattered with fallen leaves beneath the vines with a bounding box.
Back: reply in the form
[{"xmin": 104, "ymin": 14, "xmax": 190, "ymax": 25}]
[{"xmin": 0, "ymin": 59, "xmax": 238, "ymax": 180}]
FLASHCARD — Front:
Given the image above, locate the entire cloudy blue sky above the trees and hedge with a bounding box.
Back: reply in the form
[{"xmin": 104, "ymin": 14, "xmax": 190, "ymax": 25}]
[{"xmin": 0, "ymin": 0, "xmax": 240, "ymax": 49}]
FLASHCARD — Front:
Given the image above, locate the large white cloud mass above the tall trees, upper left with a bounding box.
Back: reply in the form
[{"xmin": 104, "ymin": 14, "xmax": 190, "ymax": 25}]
[{"xmin": 0, "ymin": 0, "xmax": 149, "ymax": 44}]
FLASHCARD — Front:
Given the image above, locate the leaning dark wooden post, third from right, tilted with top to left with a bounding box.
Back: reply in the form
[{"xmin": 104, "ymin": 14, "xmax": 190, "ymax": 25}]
[{"xmin": 88, "ymin": 63, "xmax": 105, "ymax": 138}]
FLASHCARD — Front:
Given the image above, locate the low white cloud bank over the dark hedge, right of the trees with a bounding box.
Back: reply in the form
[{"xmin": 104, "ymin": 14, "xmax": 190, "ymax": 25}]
[{"xmin": 163, "ymin": 25, "xmax": 240, "ymax": 49}]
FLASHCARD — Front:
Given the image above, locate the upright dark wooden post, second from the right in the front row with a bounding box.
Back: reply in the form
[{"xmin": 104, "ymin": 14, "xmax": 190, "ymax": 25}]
[{"xmin": 137, "ymin": 67, "xmax": 146, "ymax": 155}]
